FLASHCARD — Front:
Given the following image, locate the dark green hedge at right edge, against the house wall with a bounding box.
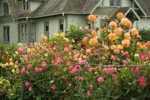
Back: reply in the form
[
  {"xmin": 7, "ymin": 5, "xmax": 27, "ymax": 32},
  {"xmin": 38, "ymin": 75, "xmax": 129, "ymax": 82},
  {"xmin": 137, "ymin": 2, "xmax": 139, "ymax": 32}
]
[{"xmin": 139, "ymin": 29, "xmax": 150, "ymax": 42}]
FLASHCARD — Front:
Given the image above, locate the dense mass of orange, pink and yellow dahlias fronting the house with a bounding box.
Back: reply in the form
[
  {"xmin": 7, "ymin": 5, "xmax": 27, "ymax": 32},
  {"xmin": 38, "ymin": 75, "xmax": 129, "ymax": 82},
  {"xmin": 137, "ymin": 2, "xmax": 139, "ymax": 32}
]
[{"xmin": 0, "ymin": 13, "xmax": 150, "ymax": 99}]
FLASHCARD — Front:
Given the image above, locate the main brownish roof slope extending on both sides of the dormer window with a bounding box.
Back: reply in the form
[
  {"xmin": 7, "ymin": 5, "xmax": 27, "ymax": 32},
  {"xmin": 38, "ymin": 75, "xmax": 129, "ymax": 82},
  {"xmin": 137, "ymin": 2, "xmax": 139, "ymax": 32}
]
[{"xmin": 7, "ymin": 0, "xmax": 101, "ymax": 18}]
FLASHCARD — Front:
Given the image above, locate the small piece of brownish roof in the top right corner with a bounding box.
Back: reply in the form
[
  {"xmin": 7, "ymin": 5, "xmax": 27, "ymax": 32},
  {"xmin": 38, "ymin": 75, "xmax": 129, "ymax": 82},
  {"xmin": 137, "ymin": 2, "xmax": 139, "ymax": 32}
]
[{"xmin": 135, "ymin": 0, "xmax": 150, "ymax": 17}]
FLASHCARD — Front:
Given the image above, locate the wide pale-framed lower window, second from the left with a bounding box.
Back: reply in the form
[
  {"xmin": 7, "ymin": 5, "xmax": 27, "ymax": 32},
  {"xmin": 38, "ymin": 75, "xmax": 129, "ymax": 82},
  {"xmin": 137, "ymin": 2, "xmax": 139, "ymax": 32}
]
[{"xmin": 19, "ymin": 24, "xmax": 28, "ymax": 41}]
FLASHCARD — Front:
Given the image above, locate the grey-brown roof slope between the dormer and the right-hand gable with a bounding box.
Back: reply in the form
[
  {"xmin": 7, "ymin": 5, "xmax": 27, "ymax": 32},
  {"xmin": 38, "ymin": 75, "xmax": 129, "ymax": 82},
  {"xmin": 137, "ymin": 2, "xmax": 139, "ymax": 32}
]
[{"xmin": 33, "ymin": 0, "xmax": 101, "ymax": 17}]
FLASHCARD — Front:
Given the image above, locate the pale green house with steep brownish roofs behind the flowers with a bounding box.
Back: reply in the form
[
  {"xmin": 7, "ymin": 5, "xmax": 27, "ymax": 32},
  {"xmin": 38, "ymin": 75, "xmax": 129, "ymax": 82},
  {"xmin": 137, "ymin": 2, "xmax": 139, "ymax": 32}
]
[{"xmin": 0, "ymin": 0, "xmax": 150, "ymax": 43}]
